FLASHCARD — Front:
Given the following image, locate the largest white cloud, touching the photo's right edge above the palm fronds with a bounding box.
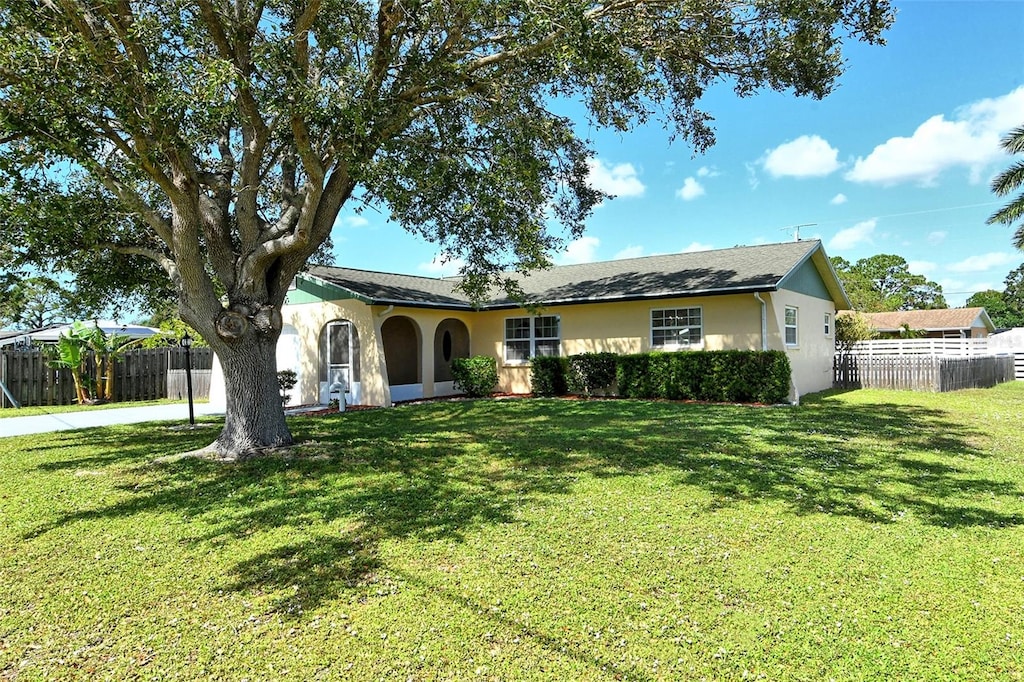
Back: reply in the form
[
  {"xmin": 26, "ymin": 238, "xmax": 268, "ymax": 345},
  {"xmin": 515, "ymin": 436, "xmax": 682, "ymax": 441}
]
[{"xmin": 846, "ymin": 86, "xmax": 1024, "ymax": 185}]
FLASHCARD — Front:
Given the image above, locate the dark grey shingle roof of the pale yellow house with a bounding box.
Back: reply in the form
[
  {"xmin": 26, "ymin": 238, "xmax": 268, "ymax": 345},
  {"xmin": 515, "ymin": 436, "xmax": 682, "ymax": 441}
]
[{"xmin": 309, "ymin": 241, "xmax": 821, "ymax": 308}]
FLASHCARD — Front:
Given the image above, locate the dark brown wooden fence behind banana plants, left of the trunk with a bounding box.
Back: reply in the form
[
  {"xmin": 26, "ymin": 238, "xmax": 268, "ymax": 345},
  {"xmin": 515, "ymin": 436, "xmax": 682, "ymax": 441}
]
[{"xmin": 0, "ymin": 347, "xmax": 213, "ymax": 408}]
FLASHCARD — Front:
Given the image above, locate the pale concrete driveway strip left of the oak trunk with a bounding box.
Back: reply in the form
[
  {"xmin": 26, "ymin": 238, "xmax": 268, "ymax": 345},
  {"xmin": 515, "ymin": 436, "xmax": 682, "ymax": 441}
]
[{"xmin": 0, "ymin": 402, "xmax": 224, "ymax": 438}]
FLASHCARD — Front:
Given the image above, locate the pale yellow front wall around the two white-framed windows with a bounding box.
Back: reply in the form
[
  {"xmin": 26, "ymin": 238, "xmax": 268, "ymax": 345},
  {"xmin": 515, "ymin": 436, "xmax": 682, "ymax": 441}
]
[{"xmin": 470, "ymin": 294, "xmax": 770, "ymax": 393}]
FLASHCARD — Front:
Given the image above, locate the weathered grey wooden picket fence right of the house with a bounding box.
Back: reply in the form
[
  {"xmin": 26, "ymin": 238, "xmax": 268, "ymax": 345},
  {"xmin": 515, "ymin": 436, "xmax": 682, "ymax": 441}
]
[{"xmin": 833, "ymin": 355, "xmax": 1014, "ymax": 392}]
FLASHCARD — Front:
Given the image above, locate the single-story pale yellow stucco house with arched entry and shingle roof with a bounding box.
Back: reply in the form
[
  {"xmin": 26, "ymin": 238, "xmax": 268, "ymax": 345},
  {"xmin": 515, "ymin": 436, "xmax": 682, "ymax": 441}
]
[{"xmin": 207, "ymin": 241, "xmax": 850, "ymax": 406}]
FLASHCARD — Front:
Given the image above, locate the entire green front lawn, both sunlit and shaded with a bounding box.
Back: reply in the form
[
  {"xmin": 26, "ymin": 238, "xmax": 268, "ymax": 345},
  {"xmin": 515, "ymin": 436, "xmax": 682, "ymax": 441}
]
[{"xmin": 0, "ymin": 384, "xmax": 1024, "ymax": 680}]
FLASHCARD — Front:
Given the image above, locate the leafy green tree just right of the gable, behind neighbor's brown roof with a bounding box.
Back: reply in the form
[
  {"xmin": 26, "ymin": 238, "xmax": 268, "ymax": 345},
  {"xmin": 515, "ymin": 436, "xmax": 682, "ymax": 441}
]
[{"xmin": 831, "ymin": 254, "xmax": 948, "ymax": 312}]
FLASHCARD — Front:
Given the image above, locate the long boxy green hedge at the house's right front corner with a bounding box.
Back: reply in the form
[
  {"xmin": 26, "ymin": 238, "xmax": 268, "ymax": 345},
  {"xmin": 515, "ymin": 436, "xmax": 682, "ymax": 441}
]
[{"xmin": 616, "ymin": 350, "xmax": 791, "ymax": 404}]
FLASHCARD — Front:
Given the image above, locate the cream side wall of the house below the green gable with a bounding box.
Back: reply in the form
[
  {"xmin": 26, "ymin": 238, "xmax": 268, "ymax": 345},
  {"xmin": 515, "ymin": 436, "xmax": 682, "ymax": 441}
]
[{"xmin": 762, "ymin": 290, "xmax": 836, "ymax": 402}]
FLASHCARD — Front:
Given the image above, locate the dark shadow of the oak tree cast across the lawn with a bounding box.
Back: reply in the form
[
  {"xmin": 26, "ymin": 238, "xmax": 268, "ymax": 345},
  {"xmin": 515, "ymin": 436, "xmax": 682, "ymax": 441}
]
[{"xmin": 19, "ymin": 387, "xmax": 1024, "ymax": 613}]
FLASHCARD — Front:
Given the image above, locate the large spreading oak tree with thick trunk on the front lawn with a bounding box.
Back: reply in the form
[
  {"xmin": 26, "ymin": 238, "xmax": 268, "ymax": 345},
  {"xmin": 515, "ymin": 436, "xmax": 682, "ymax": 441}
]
[{"xmin": 0, "ymin": 0, "xmax": 893, "ymax": 457}]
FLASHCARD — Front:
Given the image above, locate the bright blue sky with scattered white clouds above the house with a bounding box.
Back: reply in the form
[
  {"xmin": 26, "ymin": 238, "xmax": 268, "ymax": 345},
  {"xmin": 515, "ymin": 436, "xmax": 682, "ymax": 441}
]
[{"xmin": 333, "ymin": 0, "xmax": 1024, "ymax": 306}]
